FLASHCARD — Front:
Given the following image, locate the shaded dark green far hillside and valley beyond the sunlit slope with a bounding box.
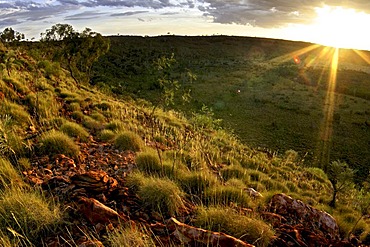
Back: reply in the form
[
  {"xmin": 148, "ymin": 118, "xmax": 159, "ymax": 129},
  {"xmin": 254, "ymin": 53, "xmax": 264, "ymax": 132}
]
[{"xmin": 94, "ymin": 36, "xmax": 370, "ymax": 180}]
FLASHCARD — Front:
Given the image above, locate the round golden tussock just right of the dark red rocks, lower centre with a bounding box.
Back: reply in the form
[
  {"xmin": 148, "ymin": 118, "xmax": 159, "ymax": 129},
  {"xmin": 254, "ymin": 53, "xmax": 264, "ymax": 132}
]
[{"xmin": 138, "ymin": 177, "xmax": 185, "ymax": 216}]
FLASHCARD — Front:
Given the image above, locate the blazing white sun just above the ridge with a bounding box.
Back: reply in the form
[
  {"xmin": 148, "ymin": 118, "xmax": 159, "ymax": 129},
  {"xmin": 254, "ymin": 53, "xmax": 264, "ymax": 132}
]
[{"xmin": 312, "ymin": 6, "xmax": 370, "ymax": 49}]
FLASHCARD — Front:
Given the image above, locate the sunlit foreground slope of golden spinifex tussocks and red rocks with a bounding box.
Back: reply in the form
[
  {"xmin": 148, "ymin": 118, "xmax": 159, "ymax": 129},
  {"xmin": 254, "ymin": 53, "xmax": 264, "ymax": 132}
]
[{"xmin": 0, "ymin": 37, "xmax": 370, "ymax": 247}]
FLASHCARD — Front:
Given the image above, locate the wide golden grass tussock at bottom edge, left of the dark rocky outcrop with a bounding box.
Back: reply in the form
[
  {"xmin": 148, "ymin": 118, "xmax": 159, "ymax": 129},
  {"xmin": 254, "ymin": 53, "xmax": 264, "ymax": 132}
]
[{"xmin": 194, "ymin": 207, "xmax": 274, "ymax": 246}]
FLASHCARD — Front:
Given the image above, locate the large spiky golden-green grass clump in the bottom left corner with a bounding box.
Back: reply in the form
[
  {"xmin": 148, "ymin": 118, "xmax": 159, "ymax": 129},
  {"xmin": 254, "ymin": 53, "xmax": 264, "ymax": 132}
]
[{"xmin": 0, "ymin": 189, "xmax": 61, "ymax": 243}]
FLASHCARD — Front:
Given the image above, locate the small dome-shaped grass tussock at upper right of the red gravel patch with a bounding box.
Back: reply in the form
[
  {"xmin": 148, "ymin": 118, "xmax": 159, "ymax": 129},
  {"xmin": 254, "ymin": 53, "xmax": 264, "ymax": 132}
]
[{"xmin": 114, "ymin": 131, "xmax": 144, "ymax": 152}]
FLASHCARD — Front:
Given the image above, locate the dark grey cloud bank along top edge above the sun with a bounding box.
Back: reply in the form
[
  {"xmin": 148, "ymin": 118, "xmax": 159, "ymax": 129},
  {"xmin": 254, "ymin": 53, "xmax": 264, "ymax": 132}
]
[{"xmin": 198, "ymin": 0, "xmax": 370, "ymax": 28}]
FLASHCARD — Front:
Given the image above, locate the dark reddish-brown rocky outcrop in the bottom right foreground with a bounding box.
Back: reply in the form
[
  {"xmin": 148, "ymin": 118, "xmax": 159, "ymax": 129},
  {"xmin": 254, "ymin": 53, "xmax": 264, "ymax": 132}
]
[{"xmin": 267, "ymin": 194, "xmax": 352, "ymax": 247}]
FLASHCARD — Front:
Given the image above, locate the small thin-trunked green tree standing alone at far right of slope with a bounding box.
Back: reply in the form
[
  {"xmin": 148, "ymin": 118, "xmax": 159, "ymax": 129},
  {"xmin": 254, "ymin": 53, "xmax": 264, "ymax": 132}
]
[{"xmin": 327, "ymin": 161, "xmax": 354, "ymax": 208}]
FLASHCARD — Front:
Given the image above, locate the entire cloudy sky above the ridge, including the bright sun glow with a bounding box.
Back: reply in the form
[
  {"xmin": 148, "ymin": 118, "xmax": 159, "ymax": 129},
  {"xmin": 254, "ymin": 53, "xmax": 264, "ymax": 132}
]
[{"xmin": 0, "ymin": 0, "xmax": 370, "ymax": 50}]
